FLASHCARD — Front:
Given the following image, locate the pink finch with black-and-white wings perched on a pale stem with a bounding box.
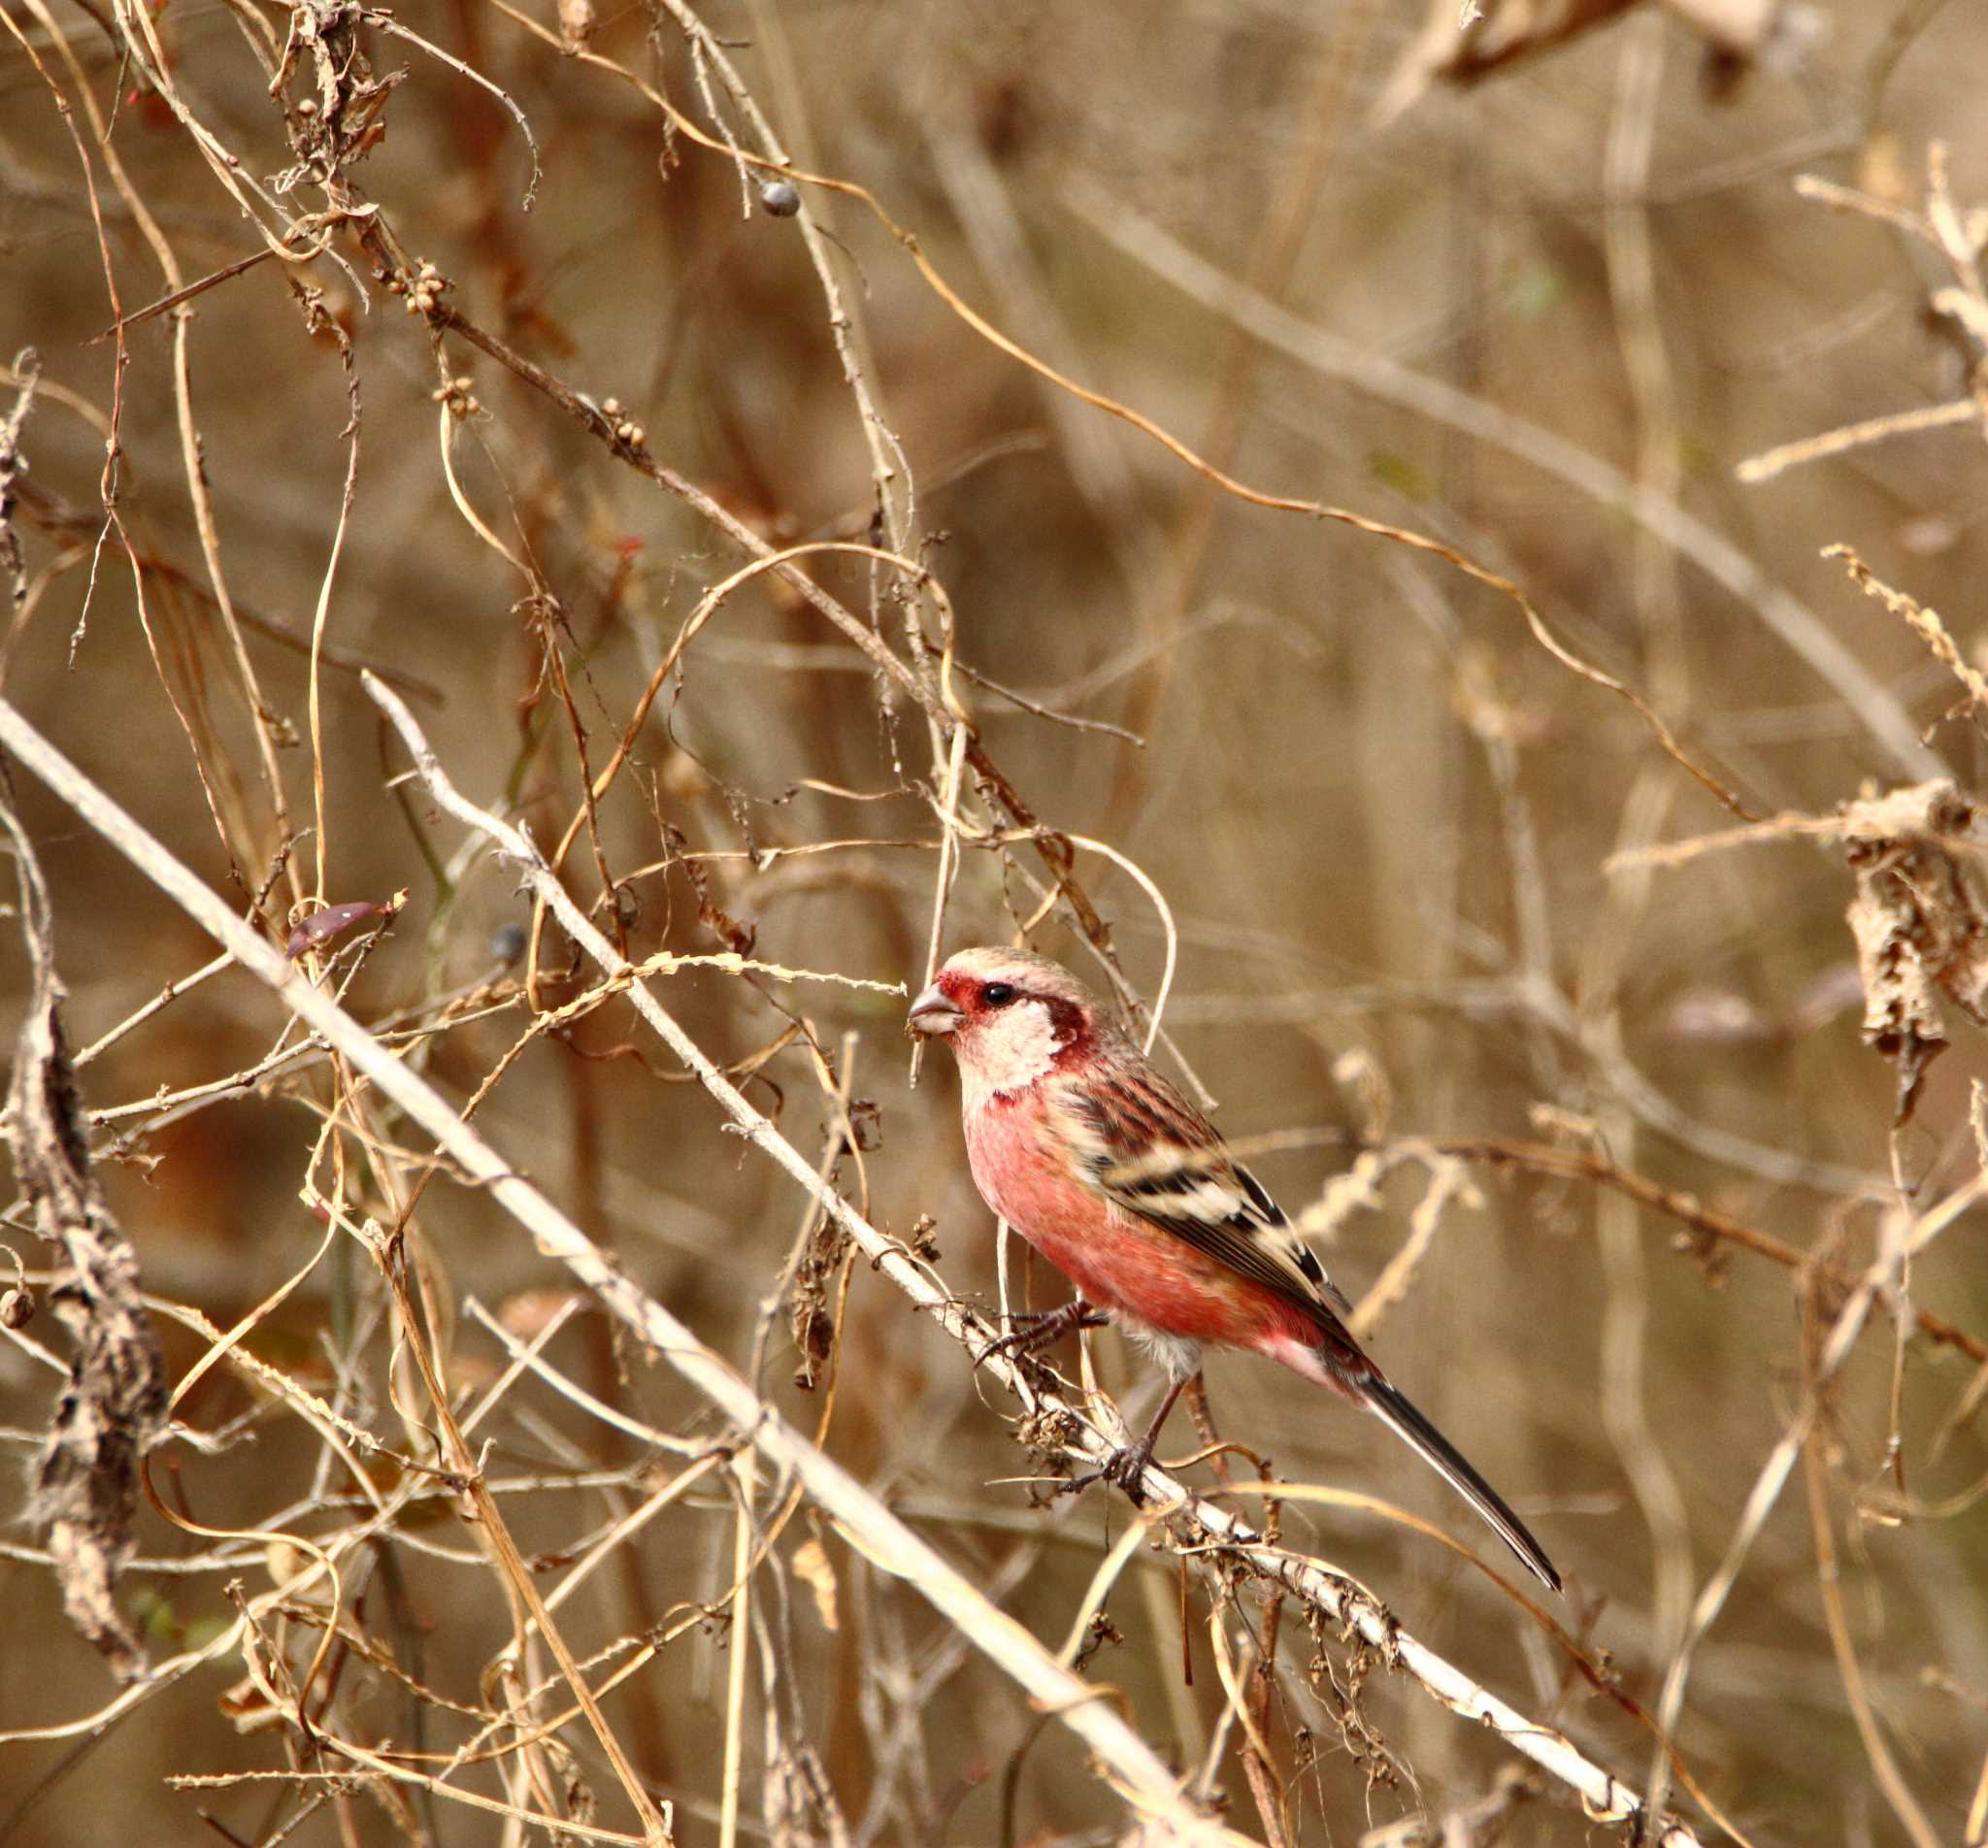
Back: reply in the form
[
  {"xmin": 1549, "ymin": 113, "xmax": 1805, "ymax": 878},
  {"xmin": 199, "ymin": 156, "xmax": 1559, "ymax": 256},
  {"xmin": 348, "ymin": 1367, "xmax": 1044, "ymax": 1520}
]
[{"xmin": 909, "ymin": 950, "xmax": 1561, "ymax": 1592}]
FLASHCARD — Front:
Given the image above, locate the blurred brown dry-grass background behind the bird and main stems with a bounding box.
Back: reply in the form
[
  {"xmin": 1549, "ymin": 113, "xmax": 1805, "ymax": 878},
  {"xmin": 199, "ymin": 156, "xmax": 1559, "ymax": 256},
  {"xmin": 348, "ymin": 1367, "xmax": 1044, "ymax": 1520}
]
[{"xmin": 0, "ymin": 0, "xmax": 1988, "ymax": 1844}]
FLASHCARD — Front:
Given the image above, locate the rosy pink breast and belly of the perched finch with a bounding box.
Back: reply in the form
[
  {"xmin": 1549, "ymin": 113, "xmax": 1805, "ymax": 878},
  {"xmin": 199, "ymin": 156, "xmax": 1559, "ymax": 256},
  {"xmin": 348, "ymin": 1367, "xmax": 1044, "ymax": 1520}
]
[{"xmin": 966, "ymin": 1093, "xmax": 1318, "ymax": 1342}]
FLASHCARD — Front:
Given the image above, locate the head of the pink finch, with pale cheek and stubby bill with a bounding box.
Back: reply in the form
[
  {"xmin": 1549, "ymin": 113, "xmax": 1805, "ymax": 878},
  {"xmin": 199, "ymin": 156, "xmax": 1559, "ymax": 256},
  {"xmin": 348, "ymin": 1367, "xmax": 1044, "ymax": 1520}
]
[{"xmin": 907, "ymin": 950, "xmax": 1108, "ymax": 1101}]
